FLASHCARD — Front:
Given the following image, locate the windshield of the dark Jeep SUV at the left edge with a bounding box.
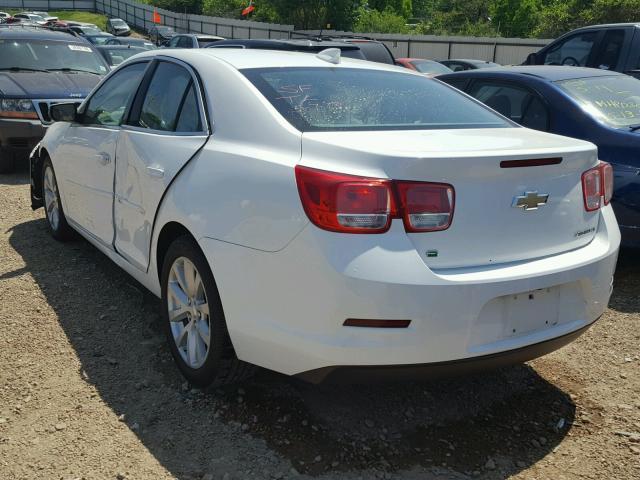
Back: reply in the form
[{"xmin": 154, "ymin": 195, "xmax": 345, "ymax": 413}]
[{"xmin": 0, "ymin": 39, "xmax": 107, "ymax": 75}]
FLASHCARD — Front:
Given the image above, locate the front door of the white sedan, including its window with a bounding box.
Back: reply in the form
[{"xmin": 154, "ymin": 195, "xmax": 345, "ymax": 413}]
[{"xmin": 56, "ymin": 63, "xmax": 147, "ymax": 246}]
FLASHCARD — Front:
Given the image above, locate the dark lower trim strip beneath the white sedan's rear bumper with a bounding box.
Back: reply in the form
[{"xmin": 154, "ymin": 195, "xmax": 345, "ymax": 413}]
[{"xmin": 296, "ymin": 322, "xmax": 595, "ymax": 383}]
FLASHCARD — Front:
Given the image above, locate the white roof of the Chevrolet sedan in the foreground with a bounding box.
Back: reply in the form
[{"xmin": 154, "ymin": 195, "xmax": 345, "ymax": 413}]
[{"xmin": 131, "ymin": 48, "xmax": 410, "ymax": 75}]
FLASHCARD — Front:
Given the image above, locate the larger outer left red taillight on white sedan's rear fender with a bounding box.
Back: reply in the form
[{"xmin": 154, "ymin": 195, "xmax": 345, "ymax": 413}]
[{"xmin": 296, "ymin": 165, "xmax": 395, "ymax": 233}]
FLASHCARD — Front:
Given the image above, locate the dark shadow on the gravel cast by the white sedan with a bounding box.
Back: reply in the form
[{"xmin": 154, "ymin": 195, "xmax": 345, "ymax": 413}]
[{"xmin": 7, "ymin": 220, "xmax": 575, "ymax": 479}]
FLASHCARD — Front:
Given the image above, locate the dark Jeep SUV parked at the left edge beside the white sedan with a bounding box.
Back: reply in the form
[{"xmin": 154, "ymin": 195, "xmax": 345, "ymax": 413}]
[{"xmin": 0, "ymin": 25, "xmax": 109, "ymax": 172}]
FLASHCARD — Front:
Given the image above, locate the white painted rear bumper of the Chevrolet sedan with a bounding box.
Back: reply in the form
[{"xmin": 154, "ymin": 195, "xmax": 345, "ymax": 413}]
[{"xmin": 200, "ymin": 207, "xmax": 620, "ymax": 378}]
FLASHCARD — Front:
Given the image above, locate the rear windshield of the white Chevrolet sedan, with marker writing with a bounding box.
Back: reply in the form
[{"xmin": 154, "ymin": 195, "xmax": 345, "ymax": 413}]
[{"xmin": 242, "ymin": 67, "xmax": 512, "ymax": 132}]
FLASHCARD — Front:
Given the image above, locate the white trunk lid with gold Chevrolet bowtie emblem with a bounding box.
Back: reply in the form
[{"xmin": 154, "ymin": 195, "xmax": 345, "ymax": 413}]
[{"xmin": 301, "ymin": 128, "xmax": 599, "ymax": 269}]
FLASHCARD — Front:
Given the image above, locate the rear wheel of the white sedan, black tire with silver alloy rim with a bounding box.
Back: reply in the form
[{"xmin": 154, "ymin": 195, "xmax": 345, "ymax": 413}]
[{"xmin": 161, "ymin": 236, "xmax": 255, "ymax": 388}]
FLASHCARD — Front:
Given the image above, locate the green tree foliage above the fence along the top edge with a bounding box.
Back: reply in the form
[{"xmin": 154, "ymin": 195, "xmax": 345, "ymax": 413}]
[{"xmin": 142, "ymin": 0, "xmax": 640, "ymax": 38}]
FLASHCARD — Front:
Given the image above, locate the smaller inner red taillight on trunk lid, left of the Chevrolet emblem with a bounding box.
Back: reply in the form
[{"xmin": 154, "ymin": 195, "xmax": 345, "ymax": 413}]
[{"xmin": 396, "ymin": 181, "xmax": 454, "ymax": 232}]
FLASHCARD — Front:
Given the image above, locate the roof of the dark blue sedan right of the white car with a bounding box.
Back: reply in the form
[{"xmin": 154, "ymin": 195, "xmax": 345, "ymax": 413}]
[{"xmin": 443, "ymin": 65, "xmax": 624, "ymax": 82}]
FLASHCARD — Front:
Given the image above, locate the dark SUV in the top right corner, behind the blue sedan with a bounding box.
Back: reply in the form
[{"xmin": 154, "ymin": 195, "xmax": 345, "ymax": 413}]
[{"xmin": 524, "ymin": 23, "xmax": 640, "ymax": 77}]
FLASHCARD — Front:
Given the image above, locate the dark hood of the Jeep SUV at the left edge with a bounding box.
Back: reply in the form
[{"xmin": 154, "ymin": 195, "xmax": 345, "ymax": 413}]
[{"xmin": 0, "ymin": 72, "xmax": 100, "ymax": 99}]
